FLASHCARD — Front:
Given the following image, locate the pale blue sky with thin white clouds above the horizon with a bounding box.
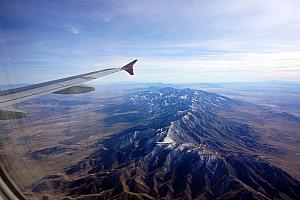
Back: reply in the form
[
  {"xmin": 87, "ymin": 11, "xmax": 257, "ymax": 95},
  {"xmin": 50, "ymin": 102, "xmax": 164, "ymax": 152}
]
[{"xmin": 0, "ymin": 0, "xmax": 300, "ymax": 84}]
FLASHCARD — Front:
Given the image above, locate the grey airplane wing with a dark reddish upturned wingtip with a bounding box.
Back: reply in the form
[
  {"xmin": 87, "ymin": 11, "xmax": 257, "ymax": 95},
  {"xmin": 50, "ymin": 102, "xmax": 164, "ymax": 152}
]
[{"xmin": 0, "ymin": 60, "xmax": 137, "ymax": 120}]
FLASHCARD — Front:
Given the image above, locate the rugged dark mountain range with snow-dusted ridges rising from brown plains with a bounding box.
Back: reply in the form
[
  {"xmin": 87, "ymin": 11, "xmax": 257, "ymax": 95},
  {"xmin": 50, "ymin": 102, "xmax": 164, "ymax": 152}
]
[{"xmin": 33, "ymin": 88, "xmax": 300, "ymax": 199}]
